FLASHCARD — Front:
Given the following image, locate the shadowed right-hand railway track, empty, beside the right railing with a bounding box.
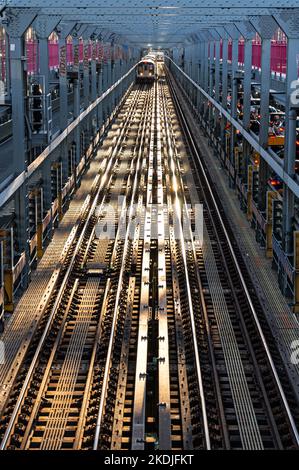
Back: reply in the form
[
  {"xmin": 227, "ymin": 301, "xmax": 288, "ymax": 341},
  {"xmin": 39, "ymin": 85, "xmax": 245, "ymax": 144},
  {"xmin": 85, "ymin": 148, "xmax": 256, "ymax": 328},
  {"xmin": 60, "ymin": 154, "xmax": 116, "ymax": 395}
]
[{"xmin": 169, "ymin": 71, "xmax": 298, "ymax": 449}]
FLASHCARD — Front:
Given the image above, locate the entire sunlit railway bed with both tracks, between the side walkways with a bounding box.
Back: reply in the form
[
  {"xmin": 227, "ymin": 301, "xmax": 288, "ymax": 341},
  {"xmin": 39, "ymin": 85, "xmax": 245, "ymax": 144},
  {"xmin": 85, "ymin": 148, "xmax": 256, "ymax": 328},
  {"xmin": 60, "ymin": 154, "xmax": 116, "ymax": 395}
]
[{"xmin": 0, "ymin": 69, "xmax": 299, "ymax": 450}]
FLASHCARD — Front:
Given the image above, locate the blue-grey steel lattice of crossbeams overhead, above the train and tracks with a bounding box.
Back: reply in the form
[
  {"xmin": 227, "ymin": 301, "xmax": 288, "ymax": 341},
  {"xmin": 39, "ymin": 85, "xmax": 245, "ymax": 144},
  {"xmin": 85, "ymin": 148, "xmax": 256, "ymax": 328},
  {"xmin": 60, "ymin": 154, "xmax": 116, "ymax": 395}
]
[{"xmin": 0, "ymin": 0, "xmax": 298, "ymax": 47}]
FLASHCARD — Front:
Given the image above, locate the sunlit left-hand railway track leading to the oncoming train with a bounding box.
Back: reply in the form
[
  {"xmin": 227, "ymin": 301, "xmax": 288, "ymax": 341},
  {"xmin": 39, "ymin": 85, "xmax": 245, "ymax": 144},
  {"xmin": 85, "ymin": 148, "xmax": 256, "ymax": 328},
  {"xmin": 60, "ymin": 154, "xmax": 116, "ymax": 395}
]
[{"xmin": 1, "ymin": 88, "xmax": 149, "ymax": 449}]
